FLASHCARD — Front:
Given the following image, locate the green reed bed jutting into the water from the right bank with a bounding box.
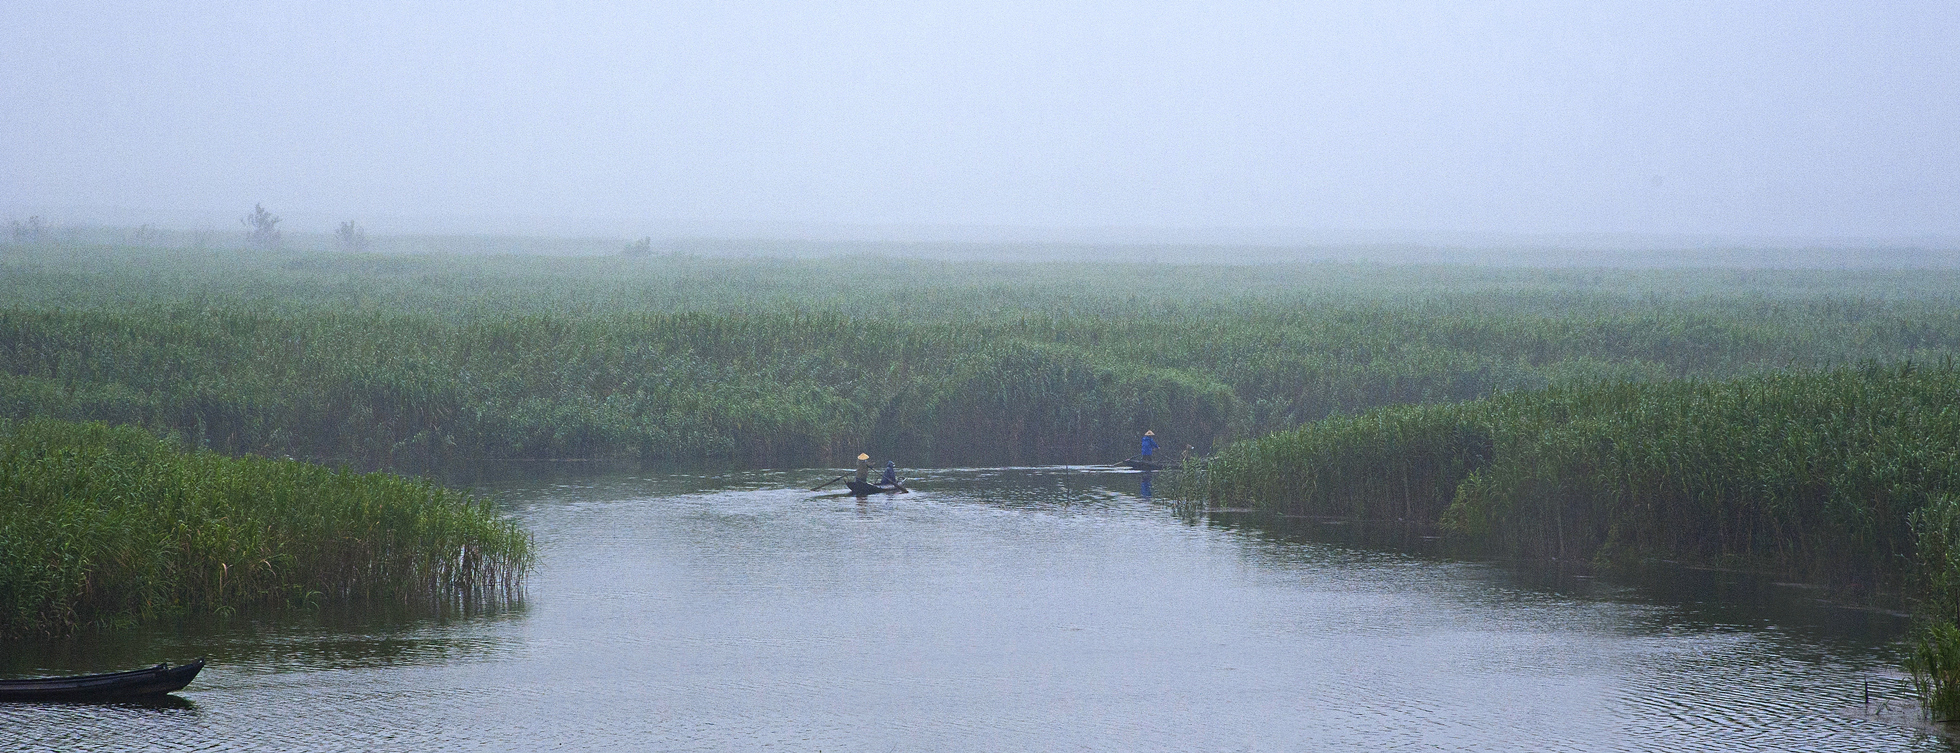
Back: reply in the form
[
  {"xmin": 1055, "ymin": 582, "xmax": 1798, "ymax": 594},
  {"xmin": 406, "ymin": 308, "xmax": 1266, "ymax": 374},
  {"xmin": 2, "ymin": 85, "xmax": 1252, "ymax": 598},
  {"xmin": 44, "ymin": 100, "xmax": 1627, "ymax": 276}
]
[{"xmin": 1184, "ymin": 361, "xmax": 1960, "ymax": 596}]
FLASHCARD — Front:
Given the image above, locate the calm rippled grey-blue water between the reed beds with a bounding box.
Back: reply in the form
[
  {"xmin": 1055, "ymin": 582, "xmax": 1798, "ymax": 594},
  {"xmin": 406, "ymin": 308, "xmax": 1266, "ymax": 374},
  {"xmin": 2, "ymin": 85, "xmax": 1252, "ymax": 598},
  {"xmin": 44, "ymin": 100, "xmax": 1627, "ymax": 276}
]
[{"xmin": 0, "ymin": 469, "xmax": 1950, "ymax": 751}]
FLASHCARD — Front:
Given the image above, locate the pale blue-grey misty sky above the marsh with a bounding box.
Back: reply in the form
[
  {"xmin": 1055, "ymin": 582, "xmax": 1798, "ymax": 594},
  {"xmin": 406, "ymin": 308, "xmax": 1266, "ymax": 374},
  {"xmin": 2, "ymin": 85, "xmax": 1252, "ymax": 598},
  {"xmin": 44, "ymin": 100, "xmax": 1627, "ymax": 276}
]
[{"xmin": 0, "ymin": 0, "xmax": 1960, "ymax": 237}]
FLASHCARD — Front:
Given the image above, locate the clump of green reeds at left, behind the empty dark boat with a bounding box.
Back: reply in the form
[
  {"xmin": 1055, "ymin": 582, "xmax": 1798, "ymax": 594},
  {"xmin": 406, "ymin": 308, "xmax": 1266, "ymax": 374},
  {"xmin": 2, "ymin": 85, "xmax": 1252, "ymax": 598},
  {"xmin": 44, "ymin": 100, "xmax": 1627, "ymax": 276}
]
[{"xmin": 0, "ymin": 420, "xmax": 531, "ymax": 635}]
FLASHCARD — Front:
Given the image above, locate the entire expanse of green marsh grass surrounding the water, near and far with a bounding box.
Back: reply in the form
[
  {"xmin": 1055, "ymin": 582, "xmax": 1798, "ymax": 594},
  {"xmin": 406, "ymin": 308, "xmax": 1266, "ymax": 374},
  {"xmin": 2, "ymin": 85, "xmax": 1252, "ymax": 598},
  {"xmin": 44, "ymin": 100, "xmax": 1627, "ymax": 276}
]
[{"xmin": 11, "ymin": 245, "xmax": 1960, "ymax": 718}]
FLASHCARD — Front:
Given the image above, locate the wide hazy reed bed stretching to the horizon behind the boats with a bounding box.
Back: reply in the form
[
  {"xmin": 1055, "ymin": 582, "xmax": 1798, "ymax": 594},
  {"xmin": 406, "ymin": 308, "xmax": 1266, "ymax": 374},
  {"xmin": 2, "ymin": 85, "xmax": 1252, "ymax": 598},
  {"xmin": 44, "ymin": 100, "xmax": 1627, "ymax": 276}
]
[{"xmin": 11, "ymin": 247, "xmax": 1960, "ymax": 469}]
